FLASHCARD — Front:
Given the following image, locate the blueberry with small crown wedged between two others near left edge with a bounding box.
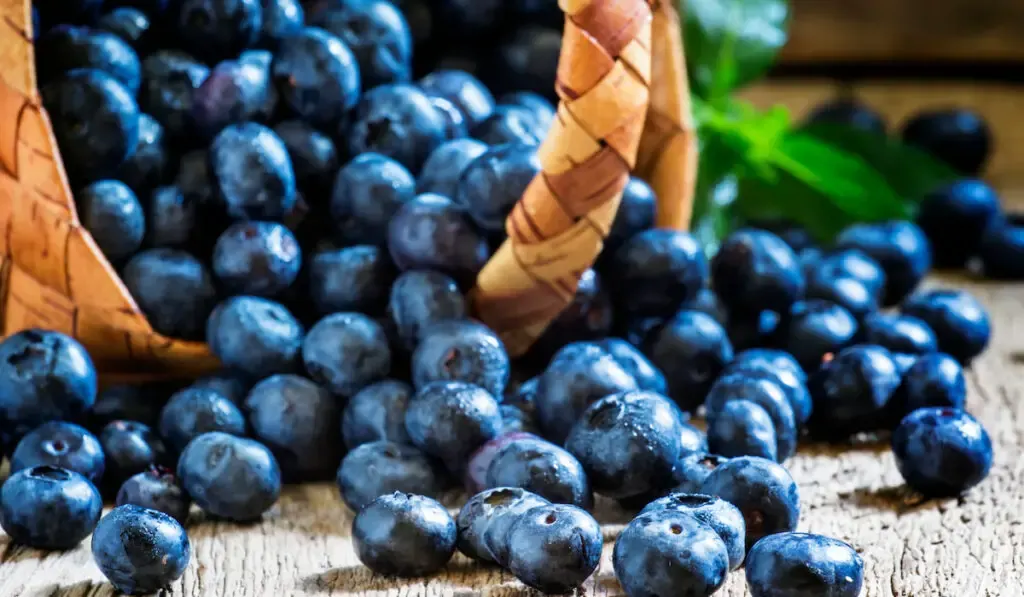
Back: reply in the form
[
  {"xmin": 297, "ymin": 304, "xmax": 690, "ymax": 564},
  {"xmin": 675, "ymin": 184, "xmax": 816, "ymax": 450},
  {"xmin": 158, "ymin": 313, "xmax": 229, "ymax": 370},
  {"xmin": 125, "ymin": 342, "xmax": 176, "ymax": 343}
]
[{"xmin": 10, "ymin": 421, "xmax": 105, "ymax": 484}]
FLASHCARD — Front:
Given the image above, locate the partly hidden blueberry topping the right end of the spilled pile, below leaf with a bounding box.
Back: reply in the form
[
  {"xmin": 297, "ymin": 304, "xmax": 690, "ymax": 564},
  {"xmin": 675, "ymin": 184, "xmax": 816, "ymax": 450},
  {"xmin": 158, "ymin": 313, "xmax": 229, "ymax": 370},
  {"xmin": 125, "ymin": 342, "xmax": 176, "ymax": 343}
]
[{"xmin": 836, "ymin": 221, "xmax": 932, "ymax": 306}]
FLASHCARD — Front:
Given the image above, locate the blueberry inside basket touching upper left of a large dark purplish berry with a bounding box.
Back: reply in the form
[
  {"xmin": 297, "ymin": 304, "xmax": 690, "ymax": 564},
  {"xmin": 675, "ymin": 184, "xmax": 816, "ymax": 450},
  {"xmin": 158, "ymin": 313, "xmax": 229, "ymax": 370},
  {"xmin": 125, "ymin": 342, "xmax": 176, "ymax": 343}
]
[{"xmin": 331, "ymin": 153, "xmax": 416, "ymax": 245}]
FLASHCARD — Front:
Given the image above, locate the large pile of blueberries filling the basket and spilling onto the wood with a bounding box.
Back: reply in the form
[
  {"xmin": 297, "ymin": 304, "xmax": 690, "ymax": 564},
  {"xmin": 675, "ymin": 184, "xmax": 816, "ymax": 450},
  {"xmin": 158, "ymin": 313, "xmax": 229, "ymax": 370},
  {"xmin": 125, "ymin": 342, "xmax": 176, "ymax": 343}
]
[{"xmin": 0, "ymin": 0, "xmax": 992, "ymax": 597}]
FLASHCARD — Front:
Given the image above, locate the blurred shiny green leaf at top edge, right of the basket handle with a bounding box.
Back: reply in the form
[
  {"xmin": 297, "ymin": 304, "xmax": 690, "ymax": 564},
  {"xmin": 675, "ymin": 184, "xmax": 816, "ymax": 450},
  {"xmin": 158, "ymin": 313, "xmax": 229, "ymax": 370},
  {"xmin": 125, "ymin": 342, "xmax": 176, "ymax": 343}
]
[{"xmin": 682, "ymin": 0, "xmax": 790, "ymax": 103}]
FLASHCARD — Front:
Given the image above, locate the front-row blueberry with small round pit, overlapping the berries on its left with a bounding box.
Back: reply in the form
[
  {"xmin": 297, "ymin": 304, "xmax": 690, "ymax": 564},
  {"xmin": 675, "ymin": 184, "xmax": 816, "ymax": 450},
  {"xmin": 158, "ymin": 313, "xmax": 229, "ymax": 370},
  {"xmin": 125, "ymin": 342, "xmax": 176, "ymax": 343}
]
[{"xmin": 506, "ymin": 504, "xmax": 603, "ymax": 594}]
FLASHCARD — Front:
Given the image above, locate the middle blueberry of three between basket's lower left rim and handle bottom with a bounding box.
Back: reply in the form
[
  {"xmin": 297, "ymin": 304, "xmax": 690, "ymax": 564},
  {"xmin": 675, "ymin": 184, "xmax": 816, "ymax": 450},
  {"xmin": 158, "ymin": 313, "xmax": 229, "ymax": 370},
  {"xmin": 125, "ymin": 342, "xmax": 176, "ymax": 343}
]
[{"xmin": 302, "ymin": 312, "xmax": 391, "ymax": 397}]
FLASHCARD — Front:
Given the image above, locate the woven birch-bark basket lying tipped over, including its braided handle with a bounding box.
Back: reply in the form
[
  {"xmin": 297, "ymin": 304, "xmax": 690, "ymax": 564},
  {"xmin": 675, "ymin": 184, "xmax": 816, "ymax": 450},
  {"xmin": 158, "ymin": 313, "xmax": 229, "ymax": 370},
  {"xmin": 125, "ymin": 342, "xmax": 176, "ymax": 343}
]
[{"xmin": 0, "ymin": 0, "xmax": 696, "ymax": 381}]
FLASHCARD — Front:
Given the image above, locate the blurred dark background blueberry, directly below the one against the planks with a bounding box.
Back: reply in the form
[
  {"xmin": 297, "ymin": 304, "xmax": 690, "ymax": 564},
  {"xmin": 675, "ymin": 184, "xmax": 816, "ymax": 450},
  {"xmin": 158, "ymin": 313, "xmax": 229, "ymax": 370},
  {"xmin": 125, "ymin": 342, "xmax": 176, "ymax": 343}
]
[{"xmin": 918, "ymin": 178, "xmax": 1001, "ymax": 267}]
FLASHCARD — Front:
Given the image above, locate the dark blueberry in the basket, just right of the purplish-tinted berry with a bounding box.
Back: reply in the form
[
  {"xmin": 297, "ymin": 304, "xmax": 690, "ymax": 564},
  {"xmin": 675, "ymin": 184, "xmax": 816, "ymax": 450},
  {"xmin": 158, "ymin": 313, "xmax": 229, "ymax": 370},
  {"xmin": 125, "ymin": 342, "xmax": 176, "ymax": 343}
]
[{"xmin": 271, "ymin": 27, "xmax": 361, "ymax": 129}]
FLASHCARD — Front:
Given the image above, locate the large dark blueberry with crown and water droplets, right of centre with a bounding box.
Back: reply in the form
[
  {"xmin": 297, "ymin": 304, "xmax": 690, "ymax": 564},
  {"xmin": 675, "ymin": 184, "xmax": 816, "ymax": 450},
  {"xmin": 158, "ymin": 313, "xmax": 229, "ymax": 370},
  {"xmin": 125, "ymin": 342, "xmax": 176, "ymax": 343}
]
[{"xmin": 565, "ymin": 391, "xmax": 682, "ymax": 498}]
